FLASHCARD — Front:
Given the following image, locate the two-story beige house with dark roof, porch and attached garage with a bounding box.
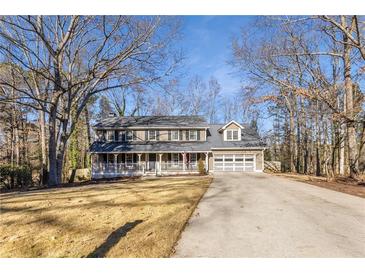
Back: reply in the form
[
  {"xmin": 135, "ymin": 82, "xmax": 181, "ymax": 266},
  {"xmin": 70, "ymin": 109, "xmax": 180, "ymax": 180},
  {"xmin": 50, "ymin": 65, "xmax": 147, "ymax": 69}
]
[{"xmin": 90, "ymin": 116, "xmax": 265, "ymax": 178}]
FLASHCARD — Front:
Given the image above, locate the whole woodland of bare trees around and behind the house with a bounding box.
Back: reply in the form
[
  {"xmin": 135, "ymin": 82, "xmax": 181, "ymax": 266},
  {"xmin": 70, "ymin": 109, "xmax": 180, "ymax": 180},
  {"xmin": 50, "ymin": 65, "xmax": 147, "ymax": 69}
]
[{"xmin": 0, "ymin": 16, "xmax": 365, "ymax": 188}]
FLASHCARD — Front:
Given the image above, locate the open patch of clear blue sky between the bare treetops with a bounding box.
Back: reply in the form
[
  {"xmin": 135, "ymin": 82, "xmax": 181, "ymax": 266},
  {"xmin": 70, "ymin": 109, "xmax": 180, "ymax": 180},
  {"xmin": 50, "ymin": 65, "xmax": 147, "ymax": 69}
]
[{"xmin": 181, "ymin": 16, "xmax": 255, "ymax": 95}]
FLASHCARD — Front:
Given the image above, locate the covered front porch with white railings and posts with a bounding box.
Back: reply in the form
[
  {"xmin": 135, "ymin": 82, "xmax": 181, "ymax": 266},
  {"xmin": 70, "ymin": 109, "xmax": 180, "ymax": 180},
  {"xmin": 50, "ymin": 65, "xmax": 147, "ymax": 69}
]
[{"xmin": 91, "ymin": 152, "xmax": 208, "ymax": 178}]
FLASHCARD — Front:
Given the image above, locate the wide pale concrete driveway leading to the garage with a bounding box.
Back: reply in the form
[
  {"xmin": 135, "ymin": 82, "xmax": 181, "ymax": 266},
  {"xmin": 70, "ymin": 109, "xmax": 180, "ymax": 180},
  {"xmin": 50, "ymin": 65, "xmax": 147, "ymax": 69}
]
[{"xmin": 174, "ymin": 173, "xmax": 365, "ymax": 257}]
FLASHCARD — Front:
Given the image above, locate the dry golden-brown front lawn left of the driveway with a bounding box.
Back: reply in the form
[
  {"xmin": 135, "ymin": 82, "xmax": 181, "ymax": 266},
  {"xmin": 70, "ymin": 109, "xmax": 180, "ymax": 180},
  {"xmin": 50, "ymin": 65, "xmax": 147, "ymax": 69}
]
[{"xmin": 0, "ymin": 177, "xmax": 211, "ymax": 257}]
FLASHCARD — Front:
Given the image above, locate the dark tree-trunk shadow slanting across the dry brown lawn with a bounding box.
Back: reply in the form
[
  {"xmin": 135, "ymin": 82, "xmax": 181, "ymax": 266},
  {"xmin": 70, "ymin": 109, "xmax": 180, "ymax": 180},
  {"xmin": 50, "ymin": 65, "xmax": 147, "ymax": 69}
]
[{"xmin": 87, "ymin": 220, "xmax": 143, "ymax": 258}]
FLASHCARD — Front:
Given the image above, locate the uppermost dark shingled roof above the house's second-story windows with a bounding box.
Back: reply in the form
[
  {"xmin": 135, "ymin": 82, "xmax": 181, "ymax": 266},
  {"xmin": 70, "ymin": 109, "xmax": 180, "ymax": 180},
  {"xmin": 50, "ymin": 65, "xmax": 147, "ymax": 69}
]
[{"xmin": 94, "ymin": 116, "xmax": 209, "ymax": 129}]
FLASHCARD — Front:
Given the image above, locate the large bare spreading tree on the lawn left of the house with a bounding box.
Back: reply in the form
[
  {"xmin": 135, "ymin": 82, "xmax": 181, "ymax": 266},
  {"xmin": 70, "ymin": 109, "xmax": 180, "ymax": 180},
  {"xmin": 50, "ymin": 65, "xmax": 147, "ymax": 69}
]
[{"xmin": 0, "ymin": 16, "xmax": 178, "ymax": 186}]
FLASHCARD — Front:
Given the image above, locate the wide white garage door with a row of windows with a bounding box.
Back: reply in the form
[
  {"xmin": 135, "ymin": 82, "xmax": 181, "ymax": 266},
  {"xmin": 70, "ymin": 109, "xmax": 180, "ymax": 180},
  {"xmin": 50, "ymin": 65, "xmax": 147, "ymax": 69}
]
[{"xmin": 214, "ymin": 154, "xmax": 255, "ymax": 171}]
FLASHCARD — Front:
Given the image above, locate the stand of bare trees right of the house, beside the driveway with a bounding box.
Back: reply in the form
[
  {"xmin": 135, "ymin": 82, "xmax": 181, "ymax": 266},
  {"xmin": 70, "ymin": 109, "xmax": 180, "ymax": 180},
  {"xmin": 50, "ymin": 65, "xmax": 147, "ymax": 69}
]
[{"xmin": 232, "ymin": 16, "xmax": 365, "ymax": 178}]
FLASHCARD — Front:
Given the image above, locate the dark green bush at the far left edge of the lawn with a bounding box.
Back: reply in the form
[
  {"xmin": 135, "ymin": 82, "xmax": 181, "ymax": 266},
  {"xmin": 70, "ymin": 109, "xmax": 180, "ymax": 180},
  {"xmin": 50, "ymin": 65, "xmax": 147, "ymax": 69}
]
[{"xmin": 0, "ymin": 165, "xmax": 32, "ymax": 189}]
